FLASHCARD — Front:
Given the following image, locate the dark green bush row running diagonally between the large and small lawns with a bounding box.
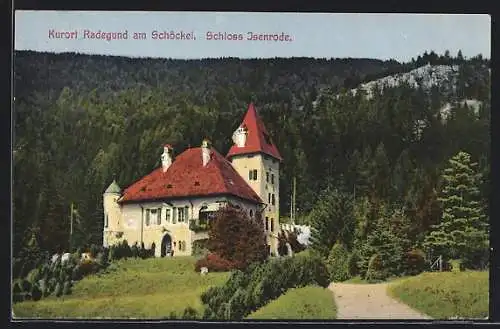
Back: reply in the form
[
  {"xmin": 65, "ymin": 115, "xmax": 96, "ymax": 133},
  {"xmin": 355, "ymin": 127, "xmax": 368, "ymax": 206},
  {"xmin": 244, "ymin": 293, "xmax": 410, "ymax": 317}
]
[{"xmin": 201, "ymin": 250, "xmax": 329, "ymax": 320}]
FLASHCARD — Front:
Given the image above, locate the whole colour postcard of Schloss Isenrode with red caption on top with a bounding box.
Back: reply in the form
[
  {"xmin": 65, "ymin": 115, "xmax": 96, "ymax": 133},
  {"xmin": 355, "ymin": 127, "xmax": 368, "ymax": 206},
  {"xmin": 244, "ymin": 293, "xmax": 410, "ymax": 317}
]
[{"xmin": 11, "ymin": 10, "xmax": 491, "ymax": 322}]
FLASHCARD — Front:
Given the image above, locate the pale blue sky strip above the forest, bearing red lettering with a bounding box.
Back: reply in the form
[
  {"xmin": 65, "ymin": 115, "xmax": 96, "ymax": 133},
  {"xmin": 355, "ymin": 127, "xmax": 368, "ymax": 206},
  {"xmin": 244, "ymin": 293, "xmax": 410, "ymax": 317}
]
[{"xmin": 14, "ymin": 11, "xmax": 491, "ymax": 61}]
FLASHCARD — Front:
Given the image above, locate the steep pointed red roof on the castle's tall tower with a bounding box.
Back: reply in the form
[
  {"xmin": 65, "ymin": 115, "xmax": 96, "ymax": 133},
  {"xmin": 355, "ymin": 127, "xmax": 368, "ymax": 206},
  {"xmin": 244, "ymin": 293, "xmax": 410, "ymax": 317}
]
[{"xmin": 227, "ymin": 103, "xmax": 282, "ymax": 161}]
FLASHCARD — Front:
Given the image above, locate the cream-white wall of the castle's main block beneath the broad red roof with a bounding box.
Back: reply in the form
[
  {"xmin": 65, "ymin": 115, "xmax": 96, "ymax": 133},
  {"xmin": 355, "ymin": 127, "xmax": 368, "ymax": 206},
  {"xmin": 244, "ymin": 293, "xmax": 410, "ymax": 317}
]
[{"xmin": 103, "ymin": 193, "xmax": 261, "ymax": 257}]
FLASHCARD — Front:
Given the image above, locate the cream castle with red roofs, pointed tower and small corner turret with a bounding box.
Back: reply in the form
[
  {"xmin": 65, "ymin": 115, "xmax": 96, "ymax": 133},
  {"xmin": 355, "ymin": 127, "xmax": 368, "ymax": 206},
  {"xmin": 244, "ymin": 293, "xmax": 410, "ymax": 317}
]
[{"xmin": 103, "ymin": 104, "xmax": 282, "ymax": 257}]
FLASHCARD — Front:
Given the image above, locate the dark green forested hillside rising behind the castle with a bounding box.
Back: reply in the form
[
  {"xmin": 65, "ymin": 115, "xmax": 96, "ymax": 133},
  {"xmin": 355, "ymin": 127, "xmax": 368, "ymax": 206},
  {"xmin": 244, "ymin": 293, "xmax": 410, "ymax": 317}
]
[{"xmin": 14, "ymin": 52, "xmax": 490, "ymax": 262}]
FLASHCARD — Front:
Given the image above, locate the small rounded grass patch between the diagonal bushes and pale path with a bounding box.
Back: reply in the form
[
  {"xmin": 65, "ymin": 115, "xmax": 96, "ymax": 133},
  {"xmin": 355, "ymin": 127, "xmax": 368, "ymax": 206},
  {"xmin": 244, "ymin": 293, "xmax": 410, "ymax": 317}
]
[{"xmin": 247, "ymin": 286, "xmax": 336, "ymax": 320}]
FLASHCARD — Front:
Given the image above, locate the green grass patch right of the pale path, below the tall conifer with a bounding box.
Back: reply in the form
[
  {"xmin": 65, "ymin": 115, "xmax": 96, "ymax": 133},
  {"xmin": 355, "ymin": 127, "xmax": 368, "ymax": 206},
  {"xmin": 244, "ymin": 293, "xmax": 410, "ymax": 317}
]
[{"xmin": 388, "ymin": 271, "xmax": 489, "ymax": 319}]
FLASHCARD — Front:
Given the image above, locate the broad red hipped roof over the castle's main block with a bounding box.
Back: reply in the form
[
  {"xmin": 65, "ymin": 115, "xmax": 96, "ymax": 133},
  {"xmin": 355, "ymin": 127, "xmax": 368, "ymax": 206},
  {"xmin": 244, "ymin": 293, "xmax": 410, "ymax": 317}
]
[{"xmin": 120, "ymin": 147, "xmax": 263, "ymax": 203}]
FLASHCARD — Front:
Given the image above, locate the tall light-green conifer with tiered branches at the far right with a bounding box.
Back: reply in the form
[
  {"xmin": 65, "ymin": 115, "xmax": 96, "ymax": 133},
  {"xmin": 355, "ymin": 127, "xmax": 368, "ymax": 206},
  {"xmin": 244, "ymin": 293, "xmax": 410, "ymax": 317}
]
[{"xmin": 424, "ymin": 152, "xmax": 488, "ymax": 266}]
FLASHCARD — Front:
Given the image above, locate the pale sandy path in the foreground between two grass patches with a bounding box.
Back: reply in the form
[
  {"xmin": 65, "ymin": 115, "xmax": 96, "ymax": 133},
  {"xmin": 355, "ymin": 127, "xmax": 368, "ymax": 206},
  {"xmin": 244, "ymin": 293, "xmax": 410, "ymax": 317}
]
[{"xmin": 328, "ymin": 283, "xmax": 431, "ymax": 320}]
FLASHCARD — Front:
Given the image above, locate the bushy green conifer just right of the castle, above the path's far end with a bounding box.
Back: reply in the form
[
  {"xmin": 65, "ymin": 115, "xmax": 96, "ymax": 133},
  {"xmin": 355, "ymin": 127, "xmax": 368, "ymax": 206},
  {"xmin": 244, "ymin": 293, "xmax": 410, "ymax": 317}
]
[{"xmin": 309, "ymin": 188, "xmax": 355, "ymax": 257}]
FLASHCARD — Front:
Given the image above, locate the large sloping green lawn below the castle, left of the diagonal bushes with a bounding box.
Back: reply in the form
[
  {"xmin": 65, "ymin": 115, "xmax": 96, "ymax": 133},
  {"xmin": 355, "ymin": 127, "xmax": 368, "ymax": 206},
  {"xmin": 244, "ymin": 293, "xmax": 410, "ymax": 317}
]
[{"xmin": 13, "ymin": 257, "xmax": 228, "ymax": 319}]
